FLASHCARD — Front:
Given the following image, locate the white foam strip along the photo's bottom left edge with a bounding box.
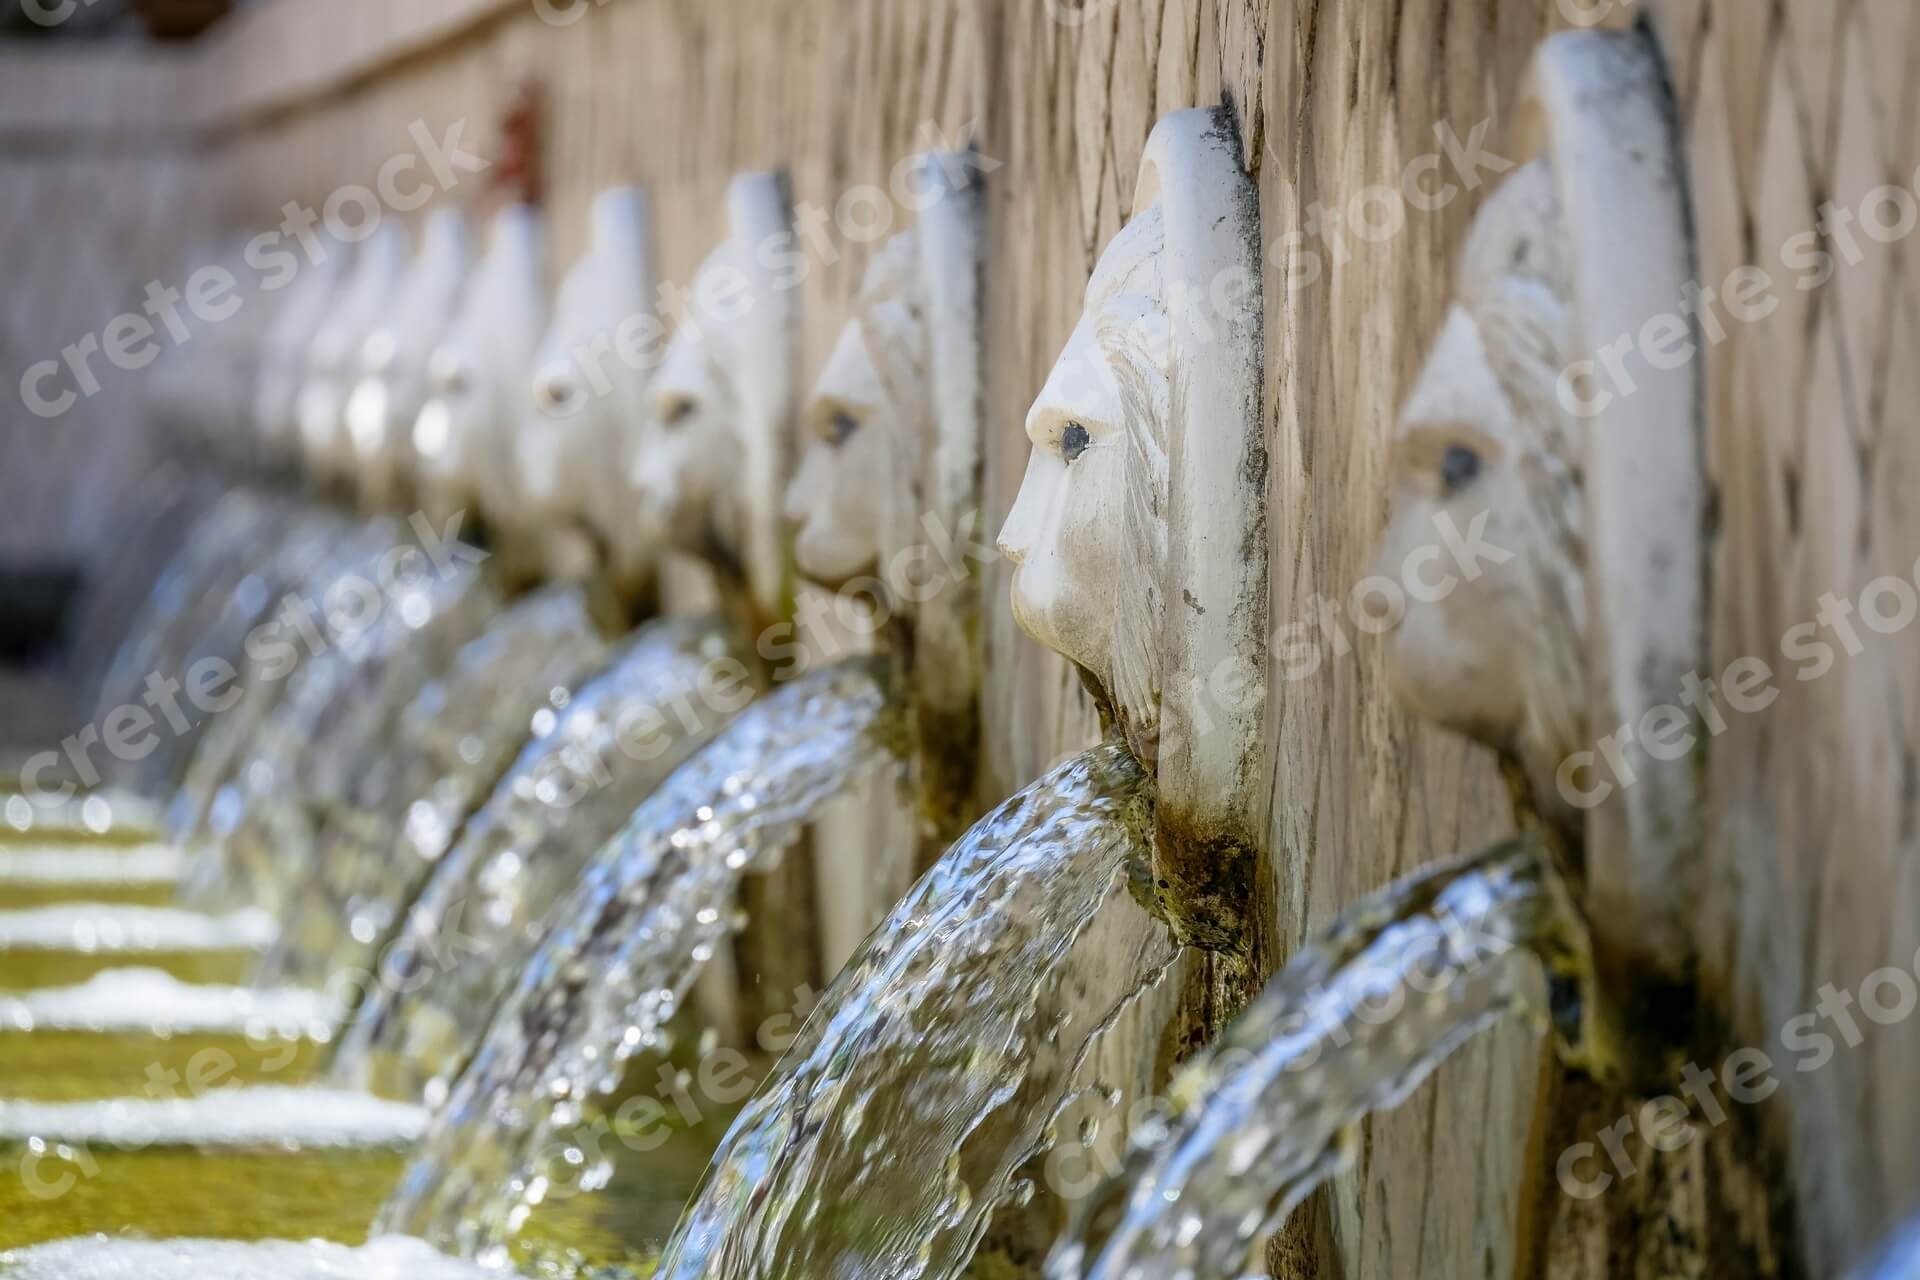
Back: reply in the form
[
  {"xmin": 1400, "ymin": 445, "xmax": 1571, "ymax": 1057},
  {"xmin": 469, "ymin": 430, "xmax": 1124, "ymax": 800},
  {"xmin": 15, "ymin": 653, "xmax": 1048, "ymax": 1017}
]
[{"xmin": 0, "ymin": 1236, "xmax": 499, "ymax": 1280}]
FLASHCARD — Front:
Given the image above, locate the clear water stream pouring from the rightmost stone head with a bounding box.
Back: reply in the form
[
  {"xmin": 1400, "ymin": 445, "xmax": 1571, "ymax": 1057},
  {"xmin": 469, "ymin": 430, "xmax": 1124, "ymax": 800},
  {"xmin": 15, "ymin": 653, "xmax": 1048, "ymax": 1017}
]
[{"xmin": 1046, "ymin": 839, "xmax": 1590, "ymax": 1280}]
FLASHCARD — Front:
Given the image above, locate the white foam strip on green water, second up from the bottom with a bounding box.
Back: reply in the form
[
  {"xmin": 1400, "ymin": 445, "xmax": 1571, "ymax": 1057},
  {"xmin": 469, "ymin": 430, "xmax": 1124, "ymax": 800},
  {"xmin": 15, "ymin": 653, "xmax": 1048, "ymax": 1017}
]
[{"xmin": 0, "ymin": 1088, "xmax": 428, "ymax": 1151}]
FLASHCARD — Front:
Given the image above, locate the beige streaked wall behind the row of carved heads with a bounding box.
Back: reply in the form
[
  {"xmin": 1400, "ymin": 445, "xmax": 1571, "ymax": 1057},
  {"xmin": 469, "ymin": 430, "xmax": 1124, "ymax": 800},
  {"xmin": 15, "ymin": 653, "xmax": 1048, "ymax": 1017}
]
[{"xmin": 0, "ymin": 0, "xmax": 1920, "ymax": 1280}]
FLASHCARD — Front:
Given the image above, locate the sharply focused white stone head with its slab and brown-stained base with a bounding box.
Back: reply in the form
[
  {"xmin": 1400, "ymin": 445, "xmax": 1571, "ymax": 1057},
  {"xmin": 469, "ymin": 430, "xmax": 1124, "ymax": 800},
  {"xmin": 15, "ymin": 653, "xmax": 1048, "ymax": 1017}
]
[{"xmin": 1000, "ymin": 109, "xmax": 1271, "ymax": 954}]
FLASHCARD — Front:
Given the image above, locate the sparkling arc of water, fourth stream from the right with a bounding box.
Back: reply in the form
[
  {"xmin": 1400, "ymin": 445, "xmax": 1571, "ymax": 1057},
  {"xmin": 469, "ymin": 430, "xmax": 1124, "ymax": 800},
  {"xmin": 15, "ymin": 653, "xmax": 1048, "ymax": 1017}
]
[{"xmin": 332, "ymin": 618, "xmax": 733, "ymax": 1103}]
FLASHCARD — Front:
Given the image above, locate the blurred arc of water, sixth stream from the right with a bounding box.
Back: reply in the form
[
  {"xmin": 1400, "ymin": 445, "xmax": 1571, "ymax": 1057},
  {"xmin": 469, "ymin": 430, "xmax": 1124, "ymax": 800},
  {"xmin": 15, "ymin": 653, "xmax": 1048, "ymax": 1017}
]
[{"xmin": 182, "ymin": 564, "xmax": 499, "ymax": 915}]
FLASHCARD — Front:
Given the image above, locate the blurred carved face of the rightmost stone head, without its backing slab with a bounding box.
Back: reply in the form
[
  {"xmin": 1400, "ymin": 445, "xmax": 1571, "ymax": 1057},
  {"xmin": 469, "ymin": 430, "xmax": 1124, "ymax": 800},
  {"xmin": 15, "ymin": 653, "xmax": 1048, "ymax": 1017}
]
[{"xmin": 1375, "ymin": 161, "xmax": 1588, "ymax": 825}]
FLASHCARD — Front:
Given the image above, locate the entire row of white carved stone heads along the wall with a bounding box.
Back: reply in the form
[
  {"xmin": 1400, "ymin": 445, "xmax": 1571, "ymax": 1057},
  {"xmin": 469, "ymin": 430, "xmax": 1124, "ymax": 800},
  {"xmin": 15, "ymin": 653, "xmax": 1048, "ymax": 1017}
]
[{"xmin": 159, "ymin": 33, "xmax": 1703, "ymax": 997}]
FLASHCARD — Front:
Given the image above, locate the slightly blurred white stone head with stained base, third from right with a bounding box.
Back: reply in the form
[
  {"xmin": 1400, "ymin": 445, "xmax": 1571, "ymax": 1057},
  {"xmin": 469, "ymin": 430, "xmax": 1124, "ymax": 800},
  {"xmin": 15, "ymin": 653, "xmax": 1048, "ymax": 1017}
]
[{"xmin": 787, "ymin": 154, "xmax": 985, "ymax": 846}]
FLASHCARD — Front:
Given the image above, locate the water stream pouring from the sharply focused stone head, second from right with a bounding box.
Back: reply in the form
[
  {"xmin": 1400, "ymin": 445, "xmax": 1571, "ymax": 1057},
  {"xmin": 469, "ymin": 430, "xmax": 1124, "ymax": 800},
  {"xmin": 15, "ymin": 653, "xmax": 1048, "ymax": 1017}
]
[{"xmin": 659, "ymin": 745, "xmax": 1177, "ymax": 1280}]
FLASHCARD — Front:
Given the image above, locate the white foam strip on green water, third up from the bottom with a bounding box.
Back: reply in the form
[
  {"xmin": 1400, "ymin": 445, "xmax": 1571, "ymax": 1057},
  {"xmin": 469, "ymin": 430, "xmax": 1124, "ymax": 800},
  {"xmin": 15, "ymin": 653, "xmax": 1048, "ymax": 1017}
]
[{"xmin": 0, "ymin": 969, "xmax": 334, "ymax": 1042}]
